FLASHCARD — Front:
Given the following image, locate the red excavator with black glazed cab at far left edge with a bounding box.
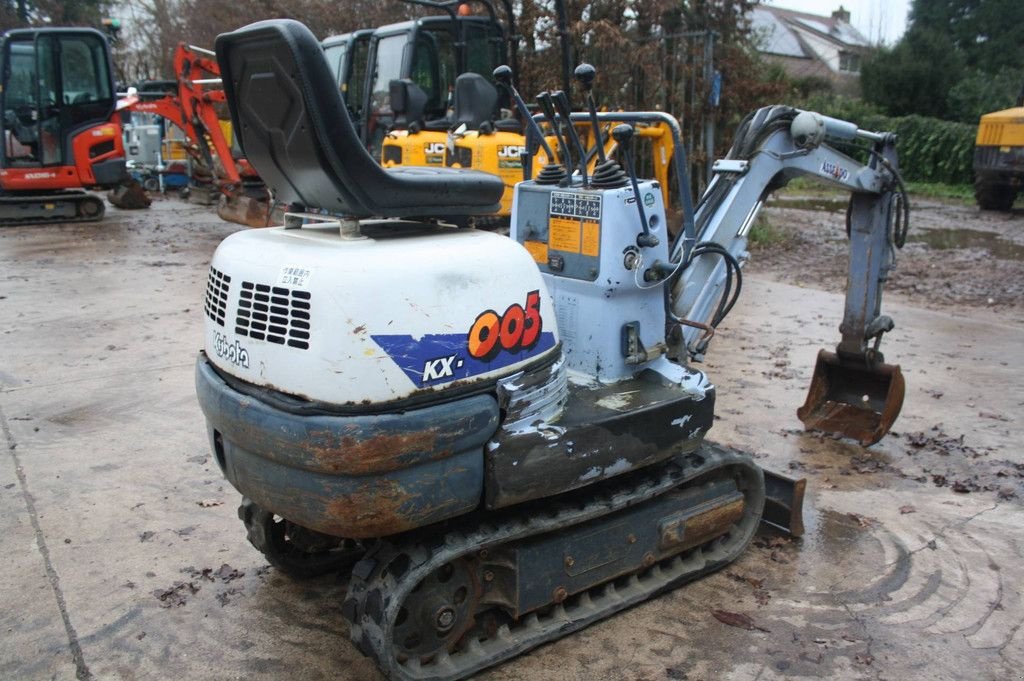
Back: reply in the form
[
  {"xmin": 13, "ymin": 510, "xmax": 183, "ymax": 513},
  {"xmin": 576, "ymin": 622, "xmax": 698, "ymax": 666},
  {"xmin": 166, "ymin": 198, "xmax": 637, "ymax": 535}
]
[{"xmin": 0, "ymin": 28, "xmax": 131, "ymax": 224}]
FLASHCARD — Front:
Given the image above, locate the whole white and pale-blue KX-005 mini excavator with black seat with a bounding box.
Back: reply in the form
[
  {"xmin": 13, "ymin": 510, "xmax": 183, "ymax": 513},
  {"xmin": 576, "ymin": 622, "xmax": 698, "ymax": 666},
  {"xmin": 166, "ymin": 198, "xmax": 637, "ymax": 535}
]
[{"xmin": 196, "ymin": 19, "xmax": 905, "ymax": 680}]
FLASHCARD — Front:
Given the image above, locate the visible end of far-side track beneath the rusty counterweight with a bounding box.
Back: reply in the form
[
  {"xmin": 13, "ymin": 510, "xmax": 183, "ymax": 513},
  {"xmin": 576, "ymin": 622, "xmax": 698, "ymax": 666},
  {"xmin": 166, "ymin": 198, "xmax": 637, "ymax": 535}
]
[{"xmin": 239, "ymin": 499, "xmax": 364, "ymax": 579}]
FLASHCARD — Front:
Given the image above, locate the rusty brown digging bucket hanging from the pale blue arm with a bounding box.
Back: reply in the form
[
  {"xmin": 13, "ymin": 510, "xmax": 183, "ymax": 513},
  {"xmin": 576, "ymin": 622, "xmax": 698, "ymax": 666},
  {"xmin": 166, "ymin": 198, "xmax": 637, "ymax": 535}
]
[{"xmin": 797, "ymin": 350, "xmax": 905, "ymax": 446}]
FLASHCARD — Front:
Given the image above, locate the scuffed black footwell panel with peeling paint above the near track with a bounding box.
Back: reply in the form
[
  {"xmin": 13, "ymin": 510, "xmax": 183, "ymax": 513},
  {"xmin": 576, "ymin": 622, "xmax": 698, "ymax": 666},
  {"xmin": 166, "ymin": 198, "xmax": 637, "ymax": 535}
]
[{"xmin": 485, "ymin": 379, "xmax": 715, "ymax": 508}]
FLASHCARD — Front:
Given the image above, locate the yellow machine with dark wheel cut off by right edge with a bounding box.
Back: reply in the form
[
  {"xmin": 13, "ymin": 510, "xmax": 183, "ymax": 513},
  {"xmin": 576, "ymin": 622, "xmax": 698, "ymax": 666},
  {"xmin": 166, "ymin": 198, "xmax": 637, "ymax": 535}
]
[{"xmin": 974, "ymin": 88, "xmax": 1024, "ymax": 211}]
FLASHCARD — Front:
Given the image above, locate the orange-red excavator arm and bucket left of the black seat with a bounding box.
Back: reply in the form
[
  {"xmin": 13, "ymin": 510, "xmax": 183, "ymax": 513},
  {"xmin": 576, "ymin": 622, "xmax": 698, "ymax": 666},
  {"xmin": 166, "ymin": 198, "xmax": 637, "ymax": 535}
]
[{"xmin": 121, "ymin": 43, "xmax": 273, "ymax": 227}]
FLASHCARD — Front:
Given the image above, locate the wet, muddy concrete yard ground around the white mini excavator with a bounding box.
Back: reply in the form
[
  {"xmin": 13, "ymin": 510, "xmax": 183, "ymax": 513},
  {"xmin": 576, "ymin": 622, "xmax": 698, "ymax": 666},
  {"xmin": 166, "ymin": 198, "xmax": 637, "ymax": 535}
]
[{"xmin": 0, "ymin": 193, "xmax": 1024, "ymax": 681}]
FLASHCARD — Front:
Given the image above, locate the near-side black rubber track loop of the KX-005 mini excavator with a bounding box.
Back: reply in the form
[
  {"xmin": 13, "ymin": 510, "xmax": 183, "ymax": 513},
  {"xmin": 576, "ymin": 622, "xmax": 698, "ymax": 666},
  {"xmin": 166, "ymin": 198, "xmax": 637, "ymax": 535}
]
[{"xmin": 342, "ymin": 443, "xmax": 764, "ymax": 681}]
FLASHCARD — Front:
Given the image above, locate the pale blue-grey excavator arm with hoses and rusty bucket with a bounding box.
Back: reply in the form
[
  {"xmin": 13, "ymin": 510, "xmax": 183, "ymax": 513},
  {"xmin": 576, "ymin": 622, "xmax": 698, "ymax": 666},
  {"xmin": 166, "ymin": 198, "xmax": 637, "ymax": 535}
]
[{"xmin": 670, "ymin": 107, "xmax": 907, "ymax": 444}]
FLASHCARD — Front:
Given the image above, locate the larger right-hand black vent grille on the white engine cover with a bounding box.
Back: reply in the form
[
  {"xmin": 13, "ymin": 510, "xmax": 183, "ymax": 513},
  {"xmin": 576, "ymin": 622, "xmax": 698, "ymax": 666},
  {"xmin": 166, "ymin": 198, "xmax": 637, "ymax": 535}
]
[{"xmin": 234, "ymin": 282, "xmax": 311, "ymax": 350}]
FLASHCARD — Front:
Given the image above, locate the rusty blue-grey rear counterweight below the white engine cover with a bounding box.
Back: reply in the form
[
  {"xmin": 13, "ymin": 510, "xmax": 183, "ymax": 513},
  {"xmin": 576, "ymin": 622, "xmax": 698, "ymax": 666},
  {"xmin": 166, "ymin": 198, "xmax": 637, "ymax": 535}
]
[{"xmin": 196, "ymin": 357, "xmax": 498, "ymax": 539}]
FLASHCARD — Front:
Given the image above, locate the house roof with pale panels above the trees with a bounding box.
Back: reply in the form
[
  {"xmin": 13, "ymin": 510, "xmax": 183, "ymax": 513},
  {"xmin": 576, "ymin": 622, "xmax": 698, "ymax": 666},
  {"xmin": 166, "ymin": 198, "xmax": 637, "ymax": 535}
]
[{"xmin": 751, "ymin": 5, "xmax": 870, "ymax": 59}]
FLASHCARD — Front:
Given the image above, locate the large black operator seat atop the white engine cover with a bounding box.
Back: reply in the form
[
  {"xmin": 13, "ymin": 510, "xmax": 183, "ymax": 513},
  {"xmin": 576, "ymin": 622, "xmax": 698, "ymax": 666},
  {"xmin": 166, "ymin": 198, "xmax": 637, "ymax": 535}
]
[{"xmin": 216, "ymin": 19, "xmax": 505, "ymax": 217}]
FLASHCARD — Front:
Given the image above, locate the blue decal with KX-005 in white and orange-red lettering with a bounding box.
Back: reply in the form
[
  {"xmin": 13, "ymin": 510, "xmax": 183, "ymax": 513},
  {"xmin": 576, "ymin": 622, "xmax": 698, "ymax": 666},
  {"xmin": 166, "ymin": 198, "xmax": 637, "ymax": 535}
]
[{"xmin": 371, "ymin": 291, "xmax": 555, "ymax": 388}]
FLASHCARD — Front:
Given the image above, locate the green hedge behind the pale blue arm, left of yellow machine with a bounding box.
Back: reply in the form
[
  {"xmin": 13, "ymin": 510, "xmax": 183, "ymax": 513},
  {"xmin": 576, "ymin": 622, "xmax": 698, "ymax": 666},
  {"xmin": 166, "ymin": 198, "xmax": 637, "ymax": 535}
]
[{"xmin": 805, "ymin": 97, "xmax": 978, "ymax": 184}]
